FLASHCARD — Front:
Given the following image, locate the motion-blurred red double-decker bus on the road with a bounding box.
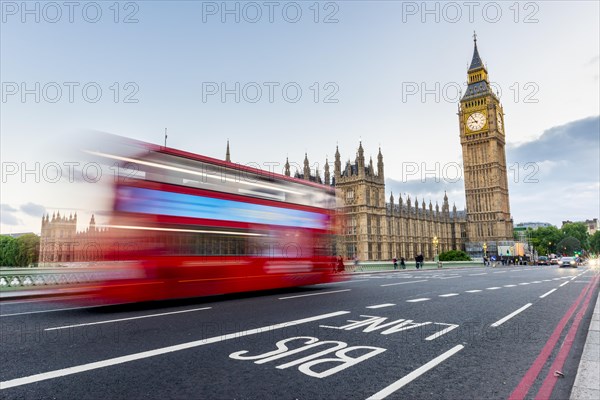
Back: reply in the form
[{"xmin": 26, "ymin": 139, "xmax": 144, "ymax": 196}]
[{"xmin": 96, "ymin": 144, "xmax": 340, "ymax": 301}]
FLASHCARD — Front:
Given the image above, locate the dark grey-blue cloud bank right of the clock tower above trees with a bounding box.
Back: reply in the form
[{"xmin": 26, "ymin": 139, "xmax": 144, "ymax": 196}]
[{"xmin": 506, "ymin": 116, "xmax": 600, "ymax": 226}]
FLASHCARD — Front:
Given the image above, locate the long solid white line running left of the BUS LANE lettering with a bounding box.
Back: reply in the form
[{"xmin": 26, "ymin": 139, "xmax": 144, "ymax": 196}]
[{"xmin": 0, "ymin": 311, "xmax": 350, "ymax": 390}]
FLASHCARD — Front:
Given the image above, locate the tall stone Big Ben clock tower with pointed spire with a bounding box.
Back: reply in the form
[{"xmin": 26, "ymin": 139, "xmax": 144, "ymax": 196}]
[{"xmin": 458, "ymin": 35, "xmax": 513, "ymax": 252}]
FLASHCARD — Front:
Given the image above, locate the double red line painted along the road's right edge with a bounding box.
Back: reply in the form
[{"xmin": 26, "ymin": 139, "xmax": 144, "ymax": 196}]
[{"xmin": 509, "ymin": 276, "xmax": 599, "ymax": 400}]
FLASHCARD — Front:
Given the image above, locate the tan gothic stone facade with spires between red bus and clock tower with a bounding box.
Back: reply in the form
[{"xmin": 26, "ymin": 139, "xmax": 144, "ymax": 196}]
[{"xmin": 285, "ymin": 143, "xmax": 466, "ymax": 260}]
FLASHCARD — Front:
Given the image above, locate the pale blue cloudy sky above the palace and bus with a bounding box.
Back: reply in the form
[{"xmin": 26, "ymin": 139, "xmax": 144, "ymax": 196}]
[{"xmin": 0, "ymin": 1, "xmax": 600, "ymax": 233}]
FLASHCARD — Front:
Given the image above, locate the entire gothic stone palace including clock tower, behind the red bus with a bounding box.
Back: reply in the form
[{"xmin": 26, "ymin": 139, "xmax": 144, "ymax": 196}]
[{"xmin": 40, "ymin": 37, "xmax": 513, "ymax": 263}]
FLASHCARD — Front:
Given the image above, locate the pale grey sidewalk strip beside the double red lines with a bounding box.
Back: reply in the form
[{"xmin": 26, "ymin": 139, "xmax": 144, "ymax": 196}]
[{"xmin": 571, "ymin": 290, "xmax": 600, "ymax": 400}]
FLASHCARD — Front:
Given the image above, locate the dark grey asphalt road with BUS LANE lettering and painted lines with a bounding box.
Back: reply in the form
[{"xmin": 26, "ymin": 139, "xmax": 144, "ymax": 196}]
[{"xmin": 0, "ymin": 266, "xmax": 598, "ymax": 399}]
